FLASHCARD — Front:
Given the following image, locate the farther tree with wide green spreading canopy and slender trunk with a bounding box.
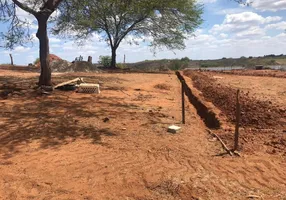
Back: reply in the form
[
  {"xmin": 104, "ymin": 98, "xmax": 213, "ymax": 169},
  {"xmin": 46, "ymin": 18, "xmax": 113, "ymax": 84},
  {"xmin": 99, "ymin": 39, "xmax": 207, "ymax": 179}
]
[{"xmin": 54, "ymin": 0, "xmax": 202, "ymax": 68}]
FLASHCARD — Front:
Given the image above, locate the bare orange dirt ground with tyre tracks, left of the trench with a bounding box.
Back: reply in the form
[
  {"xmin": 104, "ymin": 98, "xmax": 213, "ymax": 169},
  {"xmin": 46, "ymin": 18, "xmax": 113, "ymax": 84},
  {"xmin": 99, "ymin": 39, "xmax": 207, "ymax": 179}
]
[{"xmin": 0, "ymin": 71, "xmax": 286, "ymax": 200}]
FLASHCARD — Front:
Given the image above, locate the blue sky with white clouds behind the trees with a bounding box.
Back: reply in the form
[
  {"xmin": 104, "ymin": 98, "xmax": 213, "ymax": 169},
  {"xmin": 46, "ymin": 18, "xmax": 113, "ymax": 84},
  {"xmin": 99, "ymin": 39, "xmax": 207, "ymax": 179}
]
[{"xmin": 0, "ymin": 0, "xmax": 286, "ymax": 65}]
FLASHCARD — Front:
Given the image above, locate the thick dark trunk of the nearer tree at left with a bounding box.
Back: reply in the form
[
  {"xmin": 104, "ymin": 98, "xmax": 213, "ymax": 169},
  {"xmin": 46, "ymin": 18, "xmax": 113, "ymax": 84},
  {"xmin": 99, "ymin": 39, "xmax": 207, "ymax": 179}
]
[{"xmin": 36, "ymin": 13, "xmax": 52, "ymax": 86}]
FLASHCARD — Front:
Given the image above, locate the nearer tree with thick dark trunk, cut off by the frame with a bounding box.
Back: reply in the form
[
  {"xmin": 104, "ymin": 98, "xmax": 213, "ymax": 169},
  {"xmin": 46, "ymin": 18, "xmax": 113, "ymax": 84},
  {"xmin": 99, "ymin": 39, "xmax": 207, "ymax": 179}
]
[{"xmin": 0, "ymin": 0, "xmax": 64, "ymax": 86}]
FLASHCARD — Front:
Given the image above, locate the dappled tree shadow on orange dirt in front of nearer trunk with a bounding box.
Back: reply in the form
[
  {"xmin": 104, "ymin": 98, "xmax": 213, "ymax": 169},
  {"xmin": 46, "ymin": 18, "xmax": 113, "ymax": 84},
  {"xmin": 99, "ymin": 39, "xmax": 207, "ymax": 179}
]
[{"xmin": 0, "ymin": 74, "xmax": 137, "ymax": 158}]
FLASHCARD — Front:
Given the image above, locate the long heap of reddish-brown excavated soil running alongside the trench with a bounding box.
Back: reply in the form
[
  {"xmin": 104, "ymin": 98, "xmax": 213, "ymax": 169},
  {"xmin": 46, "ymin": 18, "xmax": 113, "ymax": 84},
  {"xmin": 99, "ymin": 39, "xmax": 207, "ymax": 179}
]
[{"xmin": 184, "ymin": 71, "xmax": 286, "ymax": 129}]
